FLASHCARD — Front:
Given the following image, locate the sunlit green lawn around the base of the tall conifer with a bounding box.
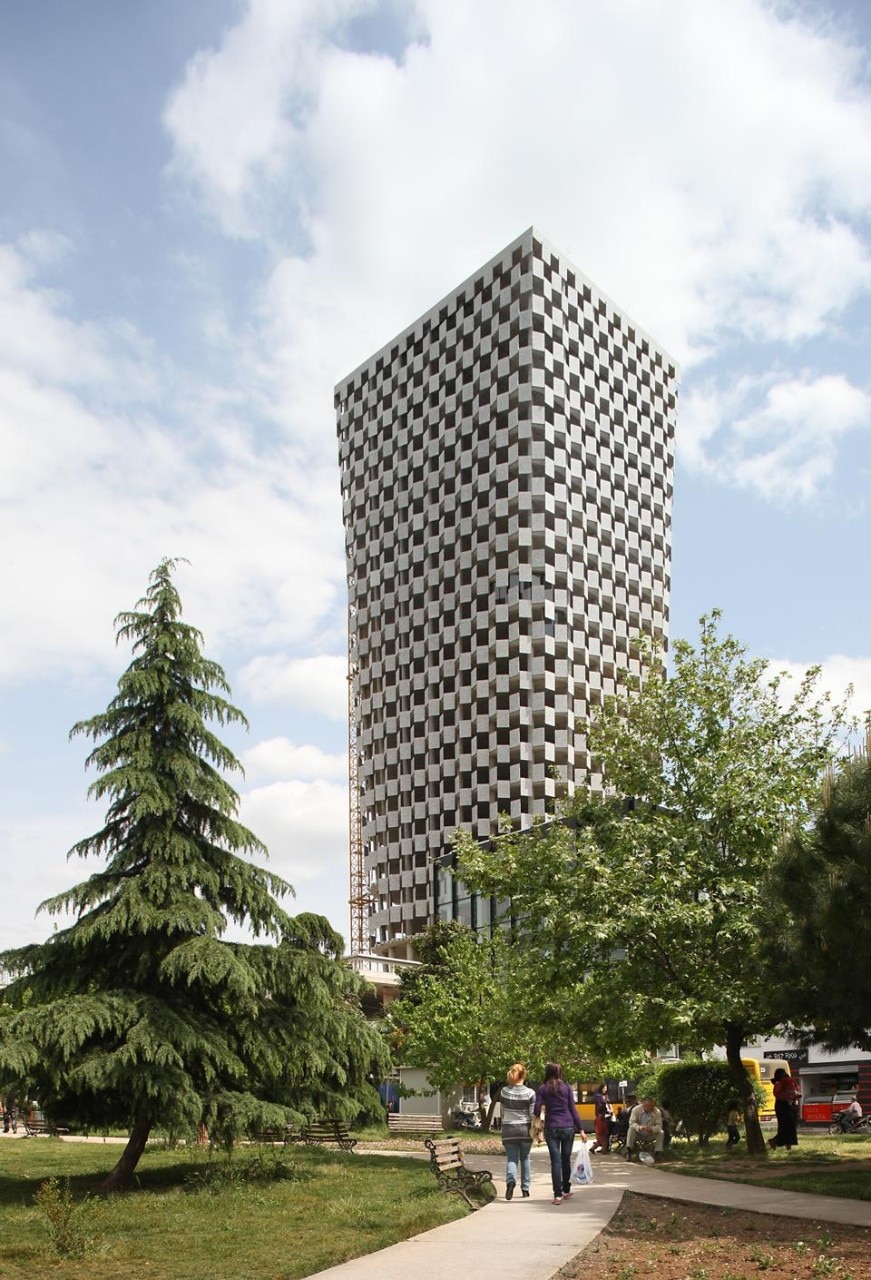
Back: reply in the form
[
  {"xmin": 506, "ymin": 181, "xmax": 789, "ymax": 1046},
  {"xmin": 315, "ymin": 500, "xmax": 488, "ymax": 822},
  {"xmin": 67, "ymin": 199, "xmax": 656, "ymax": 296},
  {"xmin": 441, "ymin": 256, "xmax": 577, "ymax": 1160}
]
[{"xmin": 0, "ymin": 1138, "xmax": 469, "ymax": 1280}]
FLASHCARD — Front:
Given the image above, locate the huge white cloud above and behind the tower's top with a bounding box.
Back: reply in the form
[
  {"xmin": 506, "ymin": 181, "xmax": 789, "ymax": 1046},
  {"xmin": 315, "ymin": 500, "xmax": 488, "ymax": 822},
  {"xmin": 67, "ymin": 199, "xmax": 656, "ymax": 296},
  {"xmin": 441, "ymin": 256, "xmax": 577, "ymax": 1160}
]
[{"xmin": 165, "ymin": 0, "xmax": 871, "ymax": 378}]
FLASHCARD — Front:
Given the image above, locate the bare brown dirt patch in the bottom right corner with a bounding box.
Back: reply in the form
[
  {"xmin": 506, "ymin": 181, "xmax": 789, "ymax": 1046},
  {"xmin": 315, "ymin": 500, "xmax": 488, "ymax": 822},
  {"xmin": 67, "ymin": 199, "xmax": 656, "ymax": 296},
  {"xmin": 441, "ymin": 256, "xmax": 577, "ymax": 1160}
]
[{"xmin": 557, "ymin": 1192, "xmax": 871, "ymax": 1280}]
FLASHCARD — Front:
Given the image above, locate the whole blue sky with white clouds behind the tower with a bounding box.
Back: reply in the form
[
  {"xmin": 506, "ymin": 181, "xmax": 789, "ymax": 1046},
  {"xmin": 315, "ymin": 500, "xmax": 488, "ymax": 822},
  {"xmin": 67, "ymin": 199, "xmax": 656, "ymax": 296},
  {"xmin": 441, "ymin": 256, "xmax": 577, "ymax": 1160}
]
[{"xmin": 0, "ymin": 0, "xmax": 871, "ymax": 947}]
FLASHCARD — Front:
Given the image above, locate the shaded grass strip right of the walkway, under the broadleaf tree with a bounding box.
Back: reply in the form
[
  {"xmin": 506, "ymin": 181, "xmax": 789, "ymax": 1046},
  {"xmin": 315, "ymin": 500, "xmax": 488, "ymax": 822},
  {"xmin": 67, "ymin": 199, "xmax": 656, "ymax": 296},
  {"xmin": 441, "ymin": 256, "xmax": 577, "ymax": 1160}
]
[{"xmin": 663, "ymin": 1130, "xmax": 871, "ymax": 1199}]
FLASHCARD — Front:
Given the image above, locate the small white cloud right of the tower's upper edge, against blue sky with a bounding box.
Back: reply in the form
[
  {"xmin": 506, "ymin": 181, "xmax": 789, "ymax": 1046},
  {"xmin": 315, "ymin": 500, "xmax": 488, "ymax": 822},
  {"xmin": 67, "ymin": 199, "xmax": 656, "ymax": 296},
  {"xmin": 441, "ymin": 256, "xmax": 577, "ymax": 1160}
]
[{"xmin": 679, "ymin": 374, "xmax": 871, "ymax": 502}]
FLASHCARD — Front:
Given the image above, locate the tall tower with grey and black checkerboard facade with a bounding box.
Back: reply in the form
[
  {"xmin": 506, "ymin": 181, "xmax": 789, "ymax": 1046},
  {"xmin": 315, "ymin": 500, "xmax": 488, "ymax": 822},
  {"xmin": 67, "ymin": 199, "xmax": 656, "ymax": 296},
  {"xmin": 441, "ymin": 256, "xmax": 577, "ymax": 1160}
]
[{"xmin": 336, "ymin": 228, "xmax": 676, "ymax": 954}]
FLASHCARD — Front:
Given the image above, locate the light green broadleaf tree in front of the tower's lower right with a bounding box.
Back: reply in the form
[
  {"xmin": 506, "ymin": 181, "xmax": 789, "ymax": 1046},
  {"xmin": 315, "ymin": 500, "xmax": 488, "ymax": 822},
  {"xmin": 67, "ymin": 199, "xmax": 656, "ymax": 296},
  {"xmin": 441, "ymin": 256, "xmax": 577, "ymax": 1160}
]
[{"xmin": 459, "ymin": 613, "xmax": 844, "ymax": 1153}]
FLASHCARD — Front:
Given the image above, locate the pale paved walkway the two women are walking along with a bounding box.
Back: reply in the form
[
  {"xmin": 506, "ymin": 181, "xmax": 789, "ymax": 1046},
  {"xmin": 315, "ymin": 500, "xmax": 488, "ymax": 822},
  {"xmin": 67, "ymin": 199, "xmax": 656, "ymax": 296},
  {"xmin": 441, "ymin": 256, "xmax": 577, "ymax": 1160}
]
[{"xmin": 310, "ymin": 1148, "xmax": 871, "ymax": 1280}]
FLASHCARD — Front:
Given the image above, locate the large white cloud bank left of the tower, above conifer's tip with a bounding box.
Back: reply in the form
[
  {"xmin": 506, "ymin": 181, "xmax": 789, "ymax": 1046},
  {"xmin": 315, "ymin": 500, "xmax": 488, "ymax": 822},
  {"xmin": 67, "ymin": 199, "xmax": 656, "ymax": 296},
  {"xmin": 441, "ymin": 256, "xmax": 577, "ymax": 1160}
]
[{"xmin": 0, "ymin": 234, "xmax": 345, "ymax": 680}]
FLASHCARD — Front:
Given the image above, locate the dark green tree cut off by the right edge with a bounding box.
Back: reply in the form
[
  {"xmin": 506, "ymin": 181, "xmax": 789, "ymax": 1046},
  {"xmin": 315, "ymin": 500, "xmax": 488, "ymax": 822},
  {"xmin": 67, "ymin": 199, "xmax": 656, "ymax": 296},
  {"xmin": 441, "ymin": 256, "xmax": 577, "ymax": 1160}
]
[{"xmin": 771, "ymin": 742, "xmax": 871, "ymax": 1051}]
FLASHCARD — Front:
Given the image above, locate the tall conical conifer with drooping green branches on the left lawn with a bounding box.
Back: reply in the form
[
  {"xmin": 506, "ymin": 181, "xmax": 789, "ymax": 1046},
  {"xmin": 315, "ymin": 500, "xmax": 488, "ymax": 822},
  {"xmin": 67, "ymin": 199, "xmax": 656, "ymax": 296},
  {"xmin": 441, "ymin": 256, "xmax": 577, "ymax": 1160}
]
[{"xmin": 0, "ymin": 561, "xmax": 383, "ymax": 1188}]
